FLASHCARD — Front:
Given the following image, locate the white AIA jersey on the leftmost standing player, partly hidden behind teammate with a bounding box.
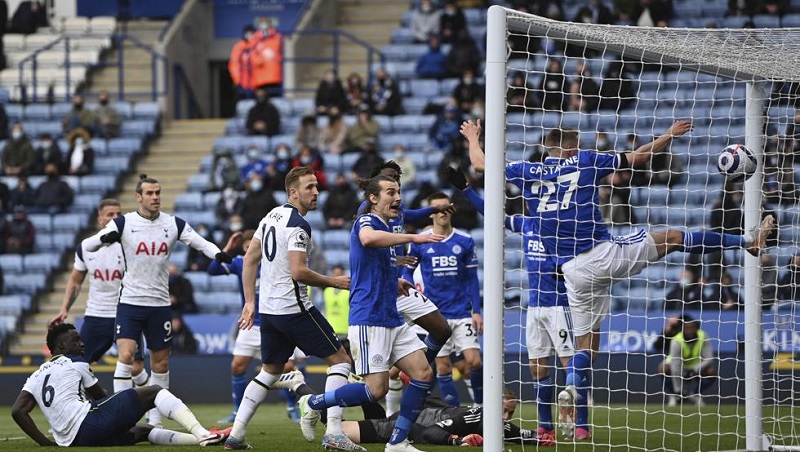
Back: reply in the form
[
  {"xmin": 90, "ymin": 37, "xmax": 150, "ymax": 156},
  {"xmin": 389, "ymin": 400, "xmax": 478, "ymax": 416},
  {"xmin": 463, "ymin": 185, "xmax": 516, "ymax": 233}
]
[{"xmin": 73, "ymin": 240, "xmax": 125, "ymax": 319}]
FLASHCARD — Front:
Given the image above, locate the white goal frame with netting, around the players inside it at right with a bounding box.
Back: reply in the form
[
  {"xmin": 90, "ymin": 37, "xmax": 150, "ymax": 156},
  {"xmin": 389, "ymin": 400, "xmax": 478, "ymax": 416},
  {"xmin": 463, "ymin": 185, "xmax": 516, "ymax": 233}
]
[{"xmin": 484, "ymin": 6, "xmax": 800, "ymax": 451}]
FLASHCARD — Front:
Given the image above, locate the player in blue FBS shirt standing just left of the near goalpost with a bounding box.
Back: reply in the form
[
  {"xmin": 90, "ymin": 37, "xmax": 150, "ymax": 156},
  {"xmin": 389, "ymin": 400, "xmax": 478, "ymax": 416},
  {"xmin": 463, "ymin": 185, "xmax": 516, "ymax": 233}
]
[{"xmin": 403, "ymin": 193, "xmax": 483, "ymax": 406}]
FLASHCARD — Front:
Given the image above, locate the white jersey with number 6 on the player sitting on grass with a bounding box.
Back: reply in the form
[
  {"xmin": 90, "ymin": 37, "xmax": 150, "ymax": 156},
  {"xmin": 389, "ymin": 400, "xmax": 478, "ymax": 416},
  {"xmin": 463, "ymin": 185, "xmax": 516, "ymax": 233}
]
[{"xmin": 22, "ymin": 355, "xmax": 97, "ymax": 446}]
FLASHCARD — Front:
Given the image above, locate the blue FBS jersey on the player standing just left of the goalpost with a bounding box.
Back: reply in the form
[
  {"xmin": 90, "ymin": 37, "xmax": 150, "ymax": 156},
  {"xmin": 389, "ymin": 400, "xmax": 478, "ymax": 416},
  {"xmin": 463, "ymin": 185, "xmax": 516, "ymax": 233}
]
[{"xmin": 406, "ymin": 229, "xmax": 480, "ymax": 319}]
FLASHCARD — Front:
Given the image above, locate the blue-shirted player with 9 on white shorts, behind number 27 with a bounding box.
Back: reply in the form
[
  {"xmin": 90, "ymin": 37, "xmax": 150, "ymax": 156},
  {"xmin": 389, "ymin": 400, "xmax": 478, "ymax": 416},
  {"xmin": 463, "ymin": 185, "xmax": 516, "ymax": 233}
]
[{"xmin": 448, "ymin": 168, "xmax": 572, "ymax": 446}]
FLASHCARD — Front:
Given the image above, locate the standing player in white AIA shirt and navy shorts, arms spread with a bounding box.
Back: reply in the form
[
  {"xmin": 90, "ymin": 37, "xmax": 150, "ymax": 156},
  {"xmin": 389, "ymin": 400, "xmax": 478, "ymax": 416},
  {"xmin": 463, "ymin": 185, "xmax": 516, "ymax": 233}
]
[{"xmin": 85, "ymin": 175, "xmax": 232, "ymax": 424}]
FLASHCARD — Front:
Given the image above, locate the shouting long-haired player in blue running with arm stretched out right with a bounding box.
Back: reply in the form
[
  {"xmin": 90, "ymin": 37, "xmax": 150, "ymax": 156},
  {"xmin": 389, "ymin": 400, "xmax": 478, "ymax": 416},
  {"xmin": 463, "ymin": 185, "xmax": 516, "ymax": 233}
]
[{"xmin": 298, "ymin": 175, "xmax": 443, "ymax": 452}]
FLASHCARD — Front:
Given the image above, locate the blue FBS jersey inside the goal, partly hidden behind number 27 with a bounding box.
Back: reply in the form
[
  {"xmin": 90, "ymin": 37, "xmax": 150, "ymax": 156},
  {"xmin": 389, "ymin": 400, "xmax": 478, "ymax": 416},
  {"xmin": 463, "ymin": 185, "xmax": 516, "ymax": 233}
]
[{"xmin": 506, "ymin": 215, "xmax": 569, "ymax": 308}]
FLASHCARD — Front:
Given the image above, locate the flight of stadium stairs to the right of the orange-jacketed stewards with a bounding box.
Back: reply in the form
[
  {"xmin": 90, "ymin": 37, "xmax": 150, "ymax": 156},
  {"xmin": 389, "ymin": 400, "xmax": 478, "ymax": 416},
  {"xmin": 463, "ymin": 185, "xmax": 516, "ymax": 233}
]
[{"xmin": 298, "ymin": 0, "xmax": 408, "ymax": 93}]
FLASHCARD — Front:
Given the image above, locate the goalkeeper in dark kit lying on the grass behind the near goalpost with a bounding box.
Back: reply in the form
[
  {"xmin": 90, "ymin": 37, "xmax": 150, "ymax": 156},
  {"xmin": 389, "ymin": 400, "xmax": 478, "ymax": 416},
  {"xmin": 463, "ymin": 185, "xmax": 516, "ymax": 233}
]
[{"xmin": 342, "ymin": 389, "xmax": 537, "ymax": 447}]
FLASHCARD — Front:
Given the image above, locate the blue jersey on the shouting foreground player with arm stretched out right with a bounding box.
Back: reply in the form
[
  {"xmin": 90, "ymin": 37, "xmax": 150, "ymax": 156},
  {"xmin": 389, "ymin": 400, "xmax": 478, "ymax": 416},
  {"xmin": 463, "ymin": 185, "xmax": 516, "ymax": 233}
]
[{"xmin": 349, "ymin": 213, "xmax": 403, "ymax": 327}]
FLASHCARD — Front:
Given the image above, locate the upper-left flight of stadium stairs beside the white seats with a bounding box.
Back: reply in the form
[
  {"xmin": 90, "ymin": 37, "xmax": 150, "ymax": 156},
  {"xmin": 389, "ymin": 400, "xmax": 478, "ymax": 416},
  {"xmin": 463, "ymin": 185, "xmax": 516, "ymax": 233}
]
[{"xmin": 88, "ymin": 20, "xmax": 167, "ymax": 102}]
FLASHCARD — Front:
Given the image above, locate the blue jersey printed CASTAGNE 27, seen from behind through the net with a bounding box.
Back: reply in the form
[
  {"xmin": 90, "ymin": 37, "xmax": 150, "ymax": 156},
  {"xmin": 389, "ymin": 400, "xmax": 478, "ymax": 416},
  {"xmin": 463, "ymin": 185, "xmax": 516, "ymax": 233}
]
[{"xmin": 506, "ymin": 150, "xmax": 621, "ymax": 265}]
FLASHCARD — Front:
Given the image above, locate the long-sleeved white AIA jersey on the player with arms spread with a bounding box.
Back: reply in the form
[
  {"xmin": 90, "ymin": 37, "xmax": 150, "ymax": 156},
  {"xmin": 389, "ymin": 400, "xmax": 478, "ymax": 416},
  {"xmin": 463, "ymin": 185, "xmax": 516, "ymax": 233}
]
[{"xmin": 85, "ymin": 212, "xmax": 220, "ymax": 306}]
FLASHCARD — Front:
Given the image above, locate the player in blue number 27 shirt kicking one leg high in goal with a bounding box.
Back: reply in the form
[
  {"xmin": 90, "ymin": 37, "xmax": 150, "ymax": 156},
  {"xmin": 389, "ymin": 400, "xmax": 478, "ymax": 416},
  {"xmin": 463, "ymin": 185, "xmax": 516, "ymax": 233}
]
[{"xmin": 461, "ymin": 120, "xmax": 774, "ymax": 440}]
